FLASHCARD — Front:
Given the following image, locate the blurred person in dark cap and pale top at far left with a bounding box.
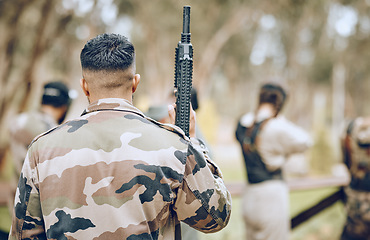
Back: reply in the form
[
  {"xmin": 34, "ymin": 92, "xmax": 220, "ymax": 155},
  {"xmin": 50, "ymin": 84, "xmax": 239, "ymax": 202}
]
[{"xmin": 9, "ymin": 81, "xmax": 72, "ymax": 178}]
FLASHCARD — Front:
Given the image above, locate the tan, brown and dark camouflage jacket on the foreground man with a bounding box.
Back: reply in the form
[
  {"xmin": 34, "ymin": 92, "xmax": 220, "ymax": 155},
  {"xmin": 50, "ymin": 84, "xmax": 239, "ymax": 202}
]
[{"xmin": 9, "ymin": 99, "xmax": 231, "ymax": 239}]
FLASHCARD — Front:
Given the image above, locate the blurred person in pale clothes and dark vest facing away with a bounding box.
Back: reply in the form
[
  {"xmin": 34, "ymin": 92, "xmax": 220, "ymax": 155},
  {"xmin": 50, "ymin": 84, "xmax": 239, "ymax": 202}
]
[{"xmin": 235, "ymin": 83, "xmax": 312, "ymax": 240}]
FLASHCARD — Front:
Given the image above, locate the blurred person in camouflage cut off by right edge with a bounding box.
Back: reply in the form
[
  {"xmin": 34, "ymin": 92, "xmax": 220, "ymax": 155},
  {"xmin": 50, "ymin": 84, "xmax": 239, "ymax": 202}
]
[{"xmin": 341, "ymin": 117, "xmax": 370, "ymax": 240}]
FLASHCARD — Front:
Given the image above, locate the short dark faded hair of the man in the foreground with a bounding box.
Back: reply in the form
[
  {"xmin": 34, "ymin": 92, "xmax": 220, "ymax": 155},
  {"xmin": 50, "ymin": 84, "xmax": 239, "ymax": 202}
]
[{"xmin": 80, "ymin": 33, "xmax": 135, "ymax": 71}]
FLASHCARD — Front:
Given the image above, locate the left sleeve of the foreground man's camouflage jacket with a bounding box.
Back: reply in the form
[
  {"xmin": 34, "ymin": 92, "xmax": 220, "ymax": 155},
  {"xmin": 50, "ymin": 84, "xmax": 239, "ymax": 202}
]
[{"xmin": 9, "ymin": 154, "xmax": 46, "ymax": 239}]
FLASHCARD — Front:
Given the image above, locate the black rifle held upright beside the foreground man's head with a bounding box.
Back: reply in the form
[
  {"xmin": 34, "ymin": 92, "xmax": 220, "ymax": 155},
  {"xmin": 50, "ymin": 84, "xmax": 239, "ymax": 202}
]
[{"xmin": 175, "ymin": 6, "xmax": 193, "ymax": 137}]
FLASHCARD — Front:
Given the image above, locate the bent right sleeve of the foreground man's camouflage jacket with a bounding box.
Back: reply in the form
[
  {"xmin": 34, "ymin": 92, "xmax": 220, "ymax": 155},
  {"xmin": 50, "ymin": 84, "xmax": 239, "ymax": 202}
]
[{"xmin": 174, "ymin": 138, "xmax": 231, "ymax": 233}]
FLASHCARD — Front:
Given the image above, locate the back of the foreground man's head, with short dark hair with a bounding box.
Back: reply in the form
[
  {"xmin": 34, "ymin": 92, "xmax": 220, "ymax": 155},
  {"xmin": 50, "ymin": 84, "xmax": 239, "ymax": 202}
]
[{"xmin": 80, "ymin": 33, "xmax": 135, "ymax": 94}]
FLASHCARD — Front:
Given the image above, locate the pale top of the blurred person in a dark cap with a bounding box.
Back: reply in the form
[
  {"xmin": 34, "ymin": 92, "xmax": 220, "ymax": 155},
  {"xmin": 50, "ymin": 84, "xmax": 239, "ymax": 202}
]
[{"xmin": 9, "ymin": 111, "xmax": 58, "ymax": 179}]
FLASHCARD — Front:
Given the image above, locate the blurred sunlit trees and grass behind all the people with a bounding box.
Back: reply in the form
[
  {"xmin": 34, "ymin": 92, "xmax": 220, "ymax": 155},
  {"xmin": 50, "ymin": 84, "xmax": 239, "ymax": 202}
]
[{"xmin": 0, "ymin": 0, "xmax": 370, "ymax": 240}]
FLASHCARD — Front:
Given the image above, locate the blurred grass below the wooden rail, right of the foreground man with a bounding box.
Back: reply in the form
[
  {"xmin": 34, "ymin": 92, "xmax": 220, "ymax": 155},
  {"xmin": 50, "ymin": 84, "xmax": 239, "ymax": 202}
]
[{"xmin": 199, "ymin": 188, "xmax": 345, "ymax": 240}]
